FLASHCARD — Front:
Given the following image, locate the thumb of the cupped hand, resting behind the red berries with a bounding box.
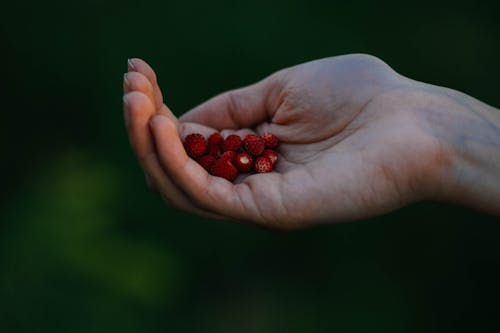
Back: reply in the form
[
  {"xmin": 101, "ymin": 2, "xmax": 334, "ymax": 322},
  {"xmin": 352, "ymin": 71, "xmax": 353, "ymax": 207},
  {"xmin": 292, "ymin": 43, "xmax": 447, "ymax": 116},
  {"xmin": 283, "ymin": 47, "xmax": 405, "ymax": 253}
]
[{"xmin": 179, "ymin": 72, "xmax": 281, "ymax": 130}]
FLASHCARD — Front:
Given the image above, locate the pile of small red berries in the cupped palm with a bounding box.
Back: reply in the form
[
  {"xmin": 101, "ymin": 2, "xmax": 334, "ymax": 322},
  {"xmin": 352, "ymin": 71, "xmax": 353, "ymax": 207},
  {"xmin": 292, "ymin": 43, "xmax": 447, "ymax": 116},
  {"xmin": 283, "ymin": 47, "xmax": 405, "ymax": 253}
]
[{"xmin": 183, "ymin": 132, "xmax": 279, "ymax": 181}]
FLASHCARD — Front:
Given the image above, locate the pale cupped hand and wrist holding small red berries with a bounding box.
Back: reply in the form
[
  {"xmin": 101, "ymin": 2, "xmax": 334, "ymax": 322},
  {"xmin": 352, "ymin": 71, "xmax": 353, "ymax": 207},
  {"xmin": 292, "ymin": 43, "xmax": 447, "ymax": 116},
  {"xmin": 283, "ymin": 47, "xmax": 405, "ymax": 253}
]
[{"xmin": 124, "ymin": 54, "xmax": 500, "ymax": 229}]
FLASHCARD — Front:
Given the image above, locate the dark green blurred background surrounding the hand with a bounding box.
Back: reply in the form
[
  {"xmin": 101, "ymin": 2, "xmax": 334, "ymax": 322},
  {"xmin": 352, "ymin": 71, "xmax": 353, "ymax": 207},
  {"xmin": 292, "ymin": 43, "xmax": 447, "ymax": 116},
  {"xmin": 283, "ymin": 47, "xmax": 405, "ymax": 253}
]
[{"xmin": 0, "ymin": 0, "xmax": 500, "ymax": 333}]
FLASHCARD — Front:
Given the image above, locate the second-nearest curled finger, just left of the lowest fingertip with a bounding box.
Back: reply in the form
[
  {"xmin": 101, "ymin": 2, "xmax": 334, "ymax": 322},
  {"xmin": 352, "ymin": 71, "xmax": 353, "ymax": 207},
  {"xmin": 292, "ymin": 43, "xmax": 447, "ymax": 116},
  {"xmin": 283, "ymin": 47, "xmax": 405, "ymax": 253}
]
[{"xmin": 123, "ymin": 91, "xmax": 221, "ymax": 218}]
